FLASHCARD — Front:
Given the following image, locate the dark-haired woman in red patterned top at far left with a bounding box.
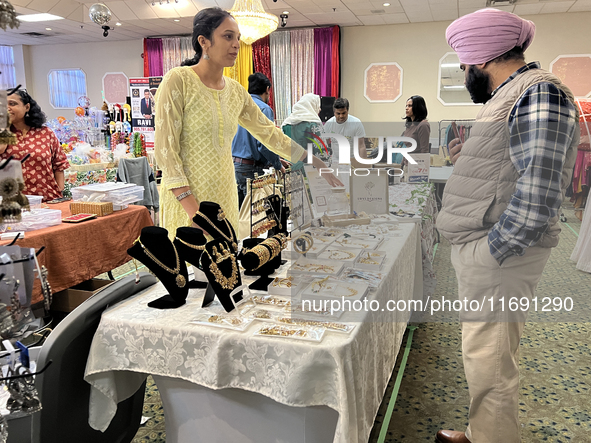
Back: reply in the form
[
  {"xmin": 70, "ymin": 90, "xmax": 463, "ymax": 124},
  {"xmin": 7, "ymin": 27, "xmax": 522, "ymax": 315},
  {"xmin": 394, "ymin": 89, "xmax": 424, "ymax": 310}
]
[{"xmin": 0, "ymin": 89, "xmax": 70, "ymax": 201}]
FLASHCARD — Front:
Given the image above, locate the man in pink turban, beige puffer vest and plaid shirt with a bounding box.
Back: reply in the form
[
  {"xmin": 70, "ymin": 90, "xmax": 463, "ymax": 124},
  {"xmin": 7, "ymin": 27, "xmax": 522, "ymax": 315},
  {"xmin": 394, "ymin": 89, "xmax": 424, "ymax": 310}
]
[{"xmin": 437, "ymin": 9, "xmax": 579, "ymax": 443}]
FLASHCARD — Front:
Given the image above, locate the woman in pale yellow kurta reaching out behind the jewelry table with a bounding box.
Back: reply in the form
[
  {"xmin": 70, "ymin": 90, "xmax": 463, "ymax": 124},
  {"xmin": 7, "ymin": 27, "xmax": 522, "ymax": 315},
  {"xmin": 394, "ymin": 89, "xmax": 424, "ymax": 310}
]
[{"xmin": 154, "ymin": 8, "xmax": 339, "ymax": 236}]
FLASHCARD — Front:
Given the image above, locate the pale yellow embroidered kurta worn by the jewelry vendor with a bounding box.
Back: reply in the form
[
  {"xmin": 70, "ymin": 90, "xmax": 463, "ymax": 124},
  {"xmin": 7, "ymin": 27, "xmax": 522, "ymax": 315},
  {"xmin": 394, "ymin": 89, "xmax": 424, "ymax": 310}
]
[{"xmin": 154, "ymin": 66, "xmax": 305, "ymax": 236}]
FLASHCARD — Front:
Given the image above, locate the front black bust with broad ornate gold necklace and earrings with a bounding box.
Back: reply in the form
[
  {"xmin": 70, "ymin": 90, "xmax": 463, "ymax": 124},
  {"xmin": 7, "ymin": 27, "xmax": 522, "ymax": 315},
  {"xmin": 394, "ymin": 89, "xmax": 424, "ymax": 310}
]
[{"xmin": 201, "ymin": 240, "xmax": 242, "ymax": 312}]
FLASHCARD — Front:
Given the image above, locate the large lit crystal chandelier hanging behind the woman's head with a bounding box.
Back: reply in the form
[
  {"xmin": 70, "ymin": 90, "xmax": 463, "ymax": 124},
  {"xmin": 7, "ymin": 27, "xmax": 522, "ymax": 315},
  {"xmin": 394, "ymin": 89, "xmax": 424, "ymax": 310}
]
[{"xmin": 228, "ymin": 0, "xmax": 279, "ymax": 45}]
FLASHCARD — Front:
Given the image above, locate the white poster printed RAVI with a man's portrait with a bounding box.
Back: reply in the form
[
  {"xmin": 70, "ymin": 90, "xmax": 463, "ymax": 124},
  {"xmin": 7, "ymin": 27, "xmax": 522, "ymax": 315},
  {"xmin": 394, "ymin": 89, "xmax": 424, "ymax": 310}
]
[{"xmin": 129, "ymin": 77, "xmax": 162, "ymax": 149}]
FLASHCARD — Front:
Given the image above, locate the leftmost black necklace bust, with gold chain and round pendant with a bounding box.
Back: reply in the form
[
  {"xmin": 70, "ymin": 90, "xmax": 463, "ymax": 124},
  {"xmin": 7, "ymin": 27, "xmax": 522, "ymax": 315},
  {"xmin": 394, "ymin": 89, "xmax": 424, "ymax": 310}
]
[{"xmin": 127, "ymin": 226, "xmax": 189, "ymax": 309}]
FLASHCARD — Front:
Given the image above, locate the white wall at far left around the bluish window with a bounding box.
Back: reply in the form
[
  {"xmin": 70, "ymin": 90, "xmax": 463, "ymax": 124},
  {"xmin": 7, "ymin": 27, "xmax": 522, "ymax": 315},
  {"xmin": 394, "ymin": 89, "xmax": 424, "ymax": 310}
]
[{"xmin": 26, "ymin": 40, "xmax": 144, "ymax": 119}]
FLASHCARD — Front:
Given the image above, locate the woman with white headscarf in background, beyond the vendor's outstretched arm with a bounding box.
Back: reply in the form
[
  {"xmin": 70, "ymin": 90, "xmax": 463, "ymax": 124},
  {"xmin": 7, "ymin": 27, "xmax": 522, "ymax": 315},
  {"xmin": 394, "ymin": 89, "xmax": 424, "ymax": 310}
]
[{"xmin": 281, "ymin": 94, "xmax": 329, "ymax": 161}]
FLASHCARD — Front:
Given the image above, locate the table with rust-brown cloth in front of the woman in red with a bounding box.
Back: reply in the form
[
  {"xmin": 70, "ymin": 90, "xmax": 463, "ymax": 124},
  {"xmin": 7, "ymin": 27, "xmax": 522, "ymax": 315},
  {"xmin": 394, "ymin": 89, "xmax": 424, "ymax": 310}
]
[{"xmin": 4, "ymin": 202, "xmax": 153, "ymax": 304}]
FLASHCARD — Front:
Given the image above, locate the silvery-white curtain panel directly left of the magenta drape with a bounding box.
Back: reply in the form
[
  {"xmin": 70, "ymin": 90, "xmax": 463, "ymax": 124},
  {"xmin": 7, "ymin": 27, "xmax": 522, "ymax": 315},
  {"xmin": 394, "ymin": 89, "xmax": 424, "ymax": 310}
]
[{"xmin": 290, "ymin": 29, "xmax": 314, "ymax": 103}]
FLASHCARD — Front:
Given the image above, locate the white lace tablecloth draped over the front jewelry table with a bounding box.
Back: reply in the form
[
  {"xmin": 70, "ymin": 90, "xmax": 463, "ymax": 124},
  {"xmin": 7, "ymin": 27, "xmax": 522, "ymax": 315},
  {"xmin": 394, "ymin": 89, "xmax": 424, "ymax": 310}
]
[{"xmin": 85, "ymin": 224, "xmax": 422, "ymax": 443}]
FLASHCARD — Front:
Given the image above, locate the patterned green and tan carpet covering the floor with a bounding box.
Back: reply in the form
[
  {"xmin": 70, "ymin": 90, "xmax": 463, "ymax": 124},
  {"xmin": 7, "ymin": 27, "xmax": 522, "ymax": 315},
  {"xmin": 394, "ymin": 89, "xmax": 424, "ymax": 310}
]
[{"xmin": 125, "ymin": 204, "xmax": 591, "ymax": 443}]
